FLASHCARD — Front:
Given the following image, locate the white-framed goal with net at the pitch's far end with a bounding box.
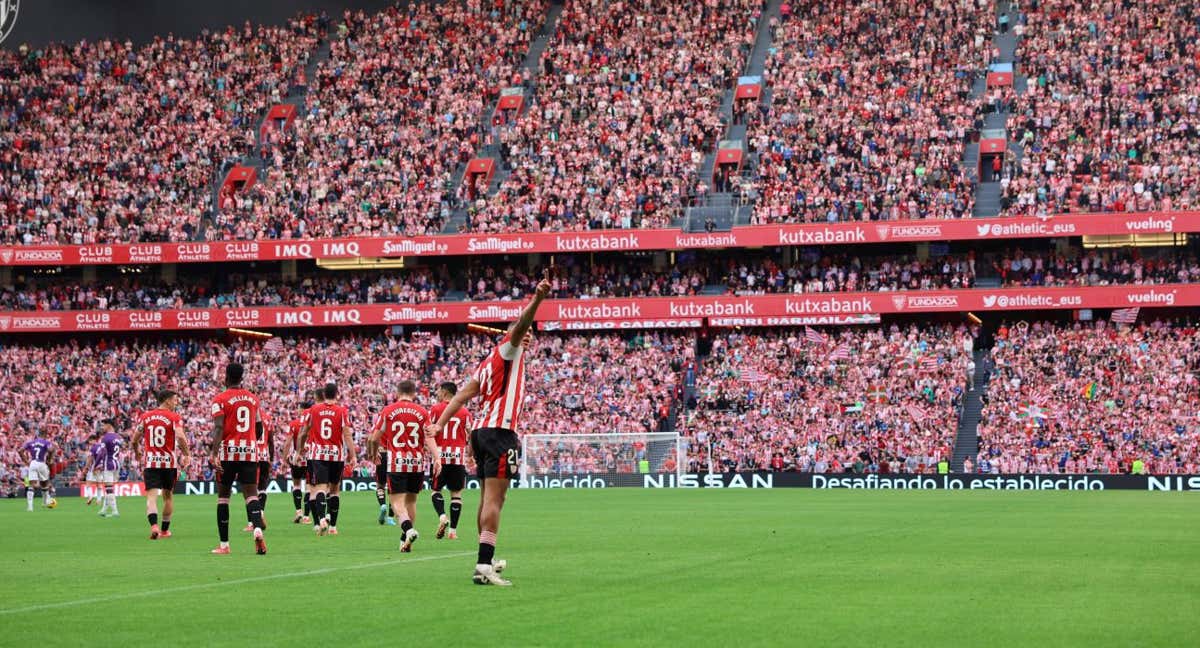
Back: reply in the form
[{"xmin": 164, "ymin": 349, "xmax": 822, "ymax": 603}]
[{"xmin": 521, "ymin": 432, "xmax": 688, "ymax": 486}]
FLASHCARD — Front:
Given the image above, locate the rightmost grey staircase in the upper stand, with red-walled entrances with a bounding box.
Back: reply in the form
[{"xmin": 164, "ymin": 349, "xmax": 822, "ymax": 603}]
[{"xmin": 962, "ymin": 0, "xmax": 1027, "ymax": 217}]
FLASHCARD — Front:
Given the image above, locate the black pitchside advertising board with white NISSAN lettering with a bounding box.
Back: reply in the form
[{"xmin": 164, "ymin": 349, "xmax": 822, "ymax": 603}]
[{"xmin": 58, "ymin": 473, "xmax": 1200, "ymax": 497}]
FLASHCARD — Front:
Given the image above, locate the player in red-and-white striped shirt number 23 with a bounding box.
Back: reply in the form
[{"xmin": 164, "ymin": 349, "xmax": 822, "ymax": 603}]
[{"xmin": 367, "ymin": 380, "xmax": 442, "ymax": 553}]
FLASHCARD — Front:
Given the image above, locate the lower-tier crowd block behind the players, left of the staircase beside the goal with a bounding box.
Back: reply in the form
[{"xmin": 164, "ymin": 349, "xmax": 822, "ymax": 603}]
[{"xmin": 0, "ymin": 332, "xmax": 694, "ymax": 479}]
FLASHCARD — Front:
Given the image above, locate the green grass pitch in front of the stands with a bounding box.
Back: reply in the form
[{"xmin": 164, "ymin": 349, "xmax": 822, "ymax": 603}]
[{"xmin": 0, "ymin": 490, "xmax": 1200, "ymax": 647}]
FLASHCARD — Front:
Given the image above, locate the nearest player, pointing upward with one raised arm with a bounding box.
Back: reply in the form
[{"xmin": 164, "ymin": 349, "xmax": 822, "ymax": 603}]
[{"xmin": 430, "ymin": 271, "xmax": 551, "ymax": 586}]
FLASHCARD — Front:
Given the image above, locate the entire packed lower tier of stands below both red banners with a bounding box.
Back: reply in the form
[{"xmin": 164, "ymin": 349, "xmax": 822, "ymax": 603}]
[{"xmin": 0, "ymin": 313, "xmax": 1200, "ymax": 493}]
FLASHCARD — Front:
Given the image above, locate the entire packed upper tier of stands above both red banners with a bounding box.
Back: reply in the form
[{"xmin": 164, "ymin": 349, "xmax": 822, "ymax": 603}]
[{"xmin": 7, "ymin": 0, "xmax": 1200, "ymax": 244}]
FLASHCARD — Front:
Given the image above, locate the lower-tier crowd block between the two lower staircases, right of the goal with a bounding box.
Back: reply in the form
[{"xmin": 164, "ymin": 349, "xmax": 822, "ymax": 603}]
[{"xmin": 686, "ymin": 325, "xmax": 974, "ymax": 473}]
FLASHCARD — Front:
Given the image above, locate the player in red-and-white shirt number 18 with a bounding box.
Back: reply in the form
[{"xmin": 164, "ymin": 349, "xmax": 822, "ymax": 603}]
[{"xmin": 133, "ymin": 390, "xmax": 187, "ymax": 540}]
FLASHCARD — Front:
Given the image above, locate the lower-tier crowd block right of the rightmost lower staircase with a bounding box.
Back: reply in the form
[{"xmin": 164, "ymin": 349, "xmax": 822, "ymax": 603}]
[{"xmin": 967, "ymin": 322, "xmax": 1200, "ymax": 474}]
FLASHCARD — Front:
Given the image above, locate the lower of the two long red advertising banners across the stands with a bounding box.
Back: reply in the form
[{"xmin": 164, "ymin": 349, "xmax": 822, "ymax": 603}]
[{"xmin": 0, "ymin": 283, "xmax": 1200, "ymax": 332}]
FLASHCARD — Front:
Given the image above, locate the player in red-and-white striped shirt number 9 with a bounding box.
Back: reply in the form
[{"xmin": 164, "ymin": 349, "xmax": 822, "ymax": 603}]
[{"xmin": 209, "ymin": 362, "xmax": 266, "ymax": 556}]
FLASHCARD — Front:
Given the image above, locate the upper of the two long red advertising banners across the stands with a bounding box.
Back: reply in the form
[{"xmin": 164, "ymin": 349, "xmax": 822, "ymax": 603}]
[{"xmin": 0, "ymin": 211, "xmax": 1200, "ymax": 265}]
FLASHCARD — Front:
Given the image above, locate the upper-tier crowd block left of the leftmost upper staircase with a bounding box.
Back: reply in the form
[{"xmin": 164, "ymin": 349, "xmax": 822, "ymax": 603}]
[{"xmin": 0, "ymin": 16, "xmax": 323, "ymax": 245}]
